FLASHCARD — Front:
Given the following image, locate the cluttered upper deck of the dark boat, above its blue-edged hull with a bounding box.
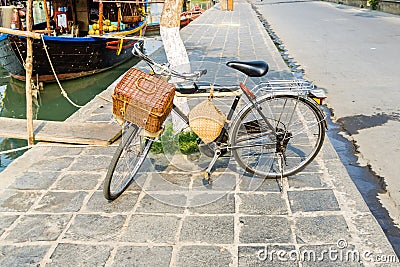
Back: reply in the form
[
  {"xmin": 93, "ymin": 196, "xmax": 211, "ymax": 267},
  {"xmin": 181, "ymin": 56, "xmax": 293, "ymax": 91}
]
[{"xmin": 0, "ymin": 0, "xmax": 146, "ymax": 37}]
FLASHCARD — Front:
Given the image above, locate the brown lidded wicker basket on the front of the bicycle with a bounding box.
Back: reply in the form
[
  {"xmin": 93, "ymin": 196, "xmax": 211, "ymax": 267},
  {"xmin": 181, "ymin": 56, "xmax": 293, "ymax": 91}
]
[{"xmin": 112, "ymin": 68, "xmax": 175, "ymax": 133}]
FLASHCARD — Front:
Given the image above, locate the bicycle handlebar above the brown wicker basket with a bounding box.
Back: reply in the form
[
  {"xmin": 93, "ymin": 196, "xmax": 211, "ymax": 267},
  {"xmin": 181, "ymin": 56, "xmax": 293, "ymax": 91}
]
[{"xmin": 132, "ymin": 42, "xmax": 207, "ymax": 81}]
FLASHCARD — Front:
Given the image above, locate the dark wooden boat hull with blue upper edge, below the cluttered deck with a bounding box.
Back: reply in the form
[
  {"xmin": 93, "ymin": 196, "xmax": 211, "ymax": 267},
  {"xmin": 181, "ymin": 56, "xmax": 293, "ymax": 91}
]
[{"xmin": 0, "ymin": 21, "xmax": 144, "ymax": 82}]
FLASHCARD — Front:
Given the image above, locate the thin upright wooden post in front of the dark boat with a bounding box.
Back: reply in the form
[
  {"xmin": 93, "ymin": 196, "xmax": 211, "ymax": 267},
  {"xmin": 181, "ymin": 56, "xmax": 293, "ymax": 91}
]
[{"xmin": 25, "ymin": 0, "xmax": 35, "ymax": 145}]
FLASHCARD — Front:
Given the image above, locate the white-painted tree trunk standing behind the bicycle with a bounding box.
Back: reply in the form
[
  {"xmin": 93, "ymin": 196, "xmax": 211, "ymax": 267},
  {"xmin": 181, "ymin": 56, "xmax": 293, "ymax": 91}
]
[{"xmin": 160, "ymin": 0, "xmax": 190, "ymax": 131}]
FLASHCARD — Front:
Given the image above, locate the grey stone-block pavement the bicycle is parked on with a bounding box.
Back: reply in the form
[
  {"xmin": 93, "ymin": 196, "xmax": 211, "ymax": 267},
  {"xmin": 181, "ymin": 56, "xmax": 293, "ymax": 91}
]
[{"xmin": 0, "ymin": 1, "xmax": 398, "ymax": 266}]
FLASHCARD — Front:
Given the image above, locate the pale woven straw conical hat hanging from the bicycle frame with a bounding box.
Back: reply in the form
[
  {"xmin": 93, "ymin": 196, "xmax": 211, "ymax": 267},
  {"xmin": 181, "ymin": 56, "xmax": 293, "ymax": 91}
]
[{"xmin": 189, "ymin": 95, "xmax": 226, "ymax": 144}]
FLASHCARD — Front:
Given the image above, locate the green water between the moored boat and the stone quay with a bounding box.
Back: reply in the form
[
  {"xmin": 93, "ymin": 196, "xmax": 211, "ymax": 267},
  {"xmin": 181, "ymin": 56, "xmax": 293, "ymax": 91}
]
[{"xmin": 0, "ymin": 40, "xmax": 161, "ymax": 172}]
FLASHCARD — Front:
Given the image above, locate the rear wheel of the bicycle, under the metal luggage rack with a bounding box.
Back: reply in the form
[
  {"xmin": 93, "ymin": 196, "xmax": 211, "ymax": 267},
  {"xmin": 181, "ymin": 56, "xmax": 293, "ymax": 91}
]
[{"xmin": 230, "ymin": 94, "xmax": 325, "ymax": 178}]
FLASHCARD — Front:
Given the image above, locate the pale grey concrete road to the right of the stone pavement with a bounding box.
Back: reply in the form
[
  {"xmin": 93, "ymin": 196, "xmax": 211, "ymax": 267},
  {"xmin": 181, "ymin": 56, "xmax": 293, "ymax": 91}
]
[{"xmin": 253, "ymin": 0, "xmax": 400, "ymax": 220}]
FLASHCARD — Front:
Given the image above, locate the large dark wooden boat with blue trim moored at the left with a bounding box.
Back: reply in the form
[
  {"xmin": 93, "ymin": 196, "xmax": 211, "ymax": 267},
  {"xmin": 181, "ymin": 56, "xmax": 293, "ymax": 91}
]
[{"xmin": 0, "ymin": 0, "xmax": 147, "ymax": 82}]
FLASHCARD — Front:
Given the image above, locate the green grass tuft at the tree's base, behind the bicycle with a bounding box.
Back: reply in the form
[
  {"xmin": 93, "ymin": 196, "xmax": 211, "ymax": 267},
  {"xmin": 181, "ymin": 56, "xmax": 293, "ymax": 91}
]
[{"xmin": 150, "ymin": 123, "xmax": 199, "ymax": 155}]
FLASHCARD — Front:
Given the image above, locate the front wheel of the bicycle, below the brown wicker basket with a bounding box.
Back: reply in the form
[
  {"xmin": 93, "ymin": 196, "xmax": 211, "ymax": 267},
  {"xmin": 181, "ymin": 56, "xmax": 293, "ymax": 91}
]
[{"xmin": 103, "ymin": 124, "xmax": 153, "ymax": 200}]
